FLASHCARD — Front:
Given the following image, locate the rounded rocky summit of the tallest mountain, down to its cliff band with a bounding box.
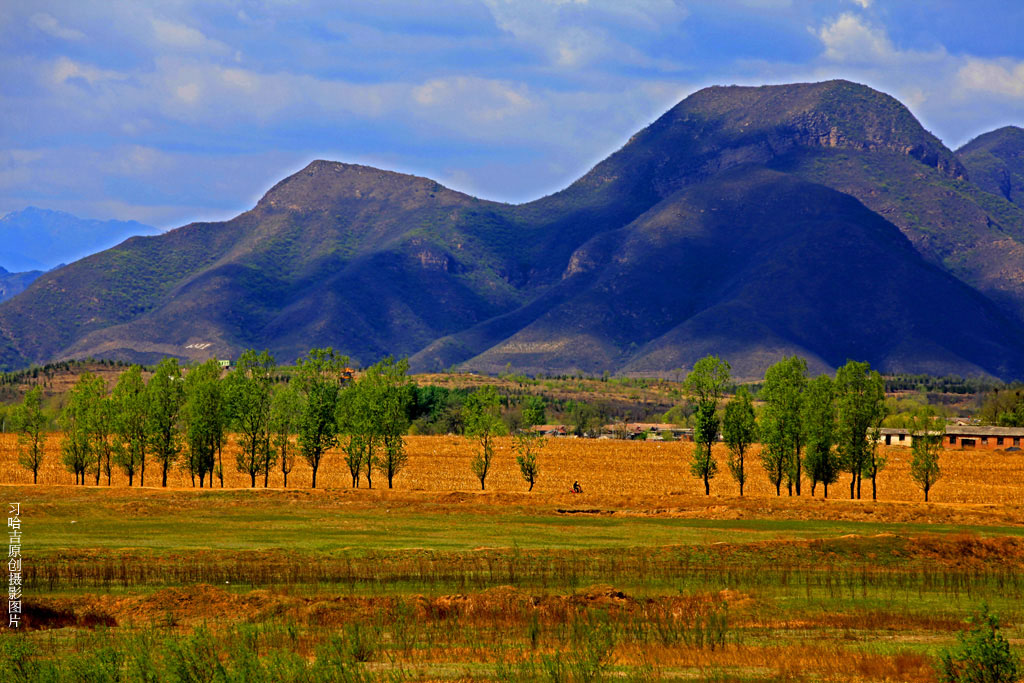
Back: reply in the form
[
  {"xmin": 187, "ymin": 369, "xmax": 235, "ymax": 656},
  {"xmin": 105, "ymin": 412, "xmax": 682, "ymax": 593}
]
[{"xmin": 574, "ymin": 80, "xmax": 967, "ymax": 209}]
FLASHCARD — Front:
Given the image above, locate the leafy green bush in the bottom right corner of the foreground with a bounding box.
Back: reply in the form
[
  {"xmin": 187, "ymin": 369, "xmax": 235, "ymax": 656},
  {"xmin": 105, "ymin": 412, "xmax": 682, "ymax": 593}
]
[{"xmin": 939, "ymin": 604, "xmax": 1024, "ymax": 683}]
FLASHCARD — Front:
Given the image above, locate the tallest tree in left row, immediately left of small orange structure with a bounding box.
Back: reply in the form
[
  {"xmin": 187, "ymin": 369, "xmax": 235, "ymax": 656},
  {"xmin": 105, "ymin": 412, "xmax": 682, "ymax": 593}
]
[{"xmin": 295, "ymin": 347, "xmax": 348, "ymax": 488}]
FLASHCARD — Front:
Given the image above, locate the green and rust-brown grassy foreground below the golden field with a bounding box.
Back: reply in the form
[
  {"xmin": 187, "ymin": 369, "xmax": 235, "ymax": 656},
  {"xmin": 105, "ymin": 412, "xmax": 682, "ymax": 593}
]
[{"xmin": 0, "ymin": 486, "xmax": 1024, "ymax": 681}]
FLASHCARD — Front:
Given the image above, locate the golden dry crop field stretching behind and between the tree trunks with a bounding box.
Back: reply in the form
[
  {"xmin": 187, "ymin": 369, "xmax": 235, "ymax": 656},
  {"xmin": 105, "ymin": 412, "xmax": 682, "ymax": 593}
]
[{"xmin": 0, "ymin": 433, "xmax": 1024, "ymax": 507}]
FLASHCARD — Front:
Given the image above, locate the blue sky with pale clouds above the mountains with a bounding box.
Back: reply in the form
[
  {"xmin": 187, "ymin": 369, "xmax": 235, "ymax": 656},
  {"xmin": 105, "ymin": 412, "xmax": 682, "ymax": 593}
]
[{"xmin": 0, "ymin": 0, "xmax": 1024, "ymax": 227}]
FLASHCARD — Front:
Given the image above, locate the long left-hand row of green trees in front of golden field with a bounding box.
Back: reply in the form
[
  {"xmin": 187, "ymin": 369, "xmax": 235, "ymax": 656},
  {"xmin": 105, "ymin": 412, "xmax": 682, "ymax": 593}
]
[{"xmin": 14, "ymin": 348, "xmax": 414, "ymax": 487}]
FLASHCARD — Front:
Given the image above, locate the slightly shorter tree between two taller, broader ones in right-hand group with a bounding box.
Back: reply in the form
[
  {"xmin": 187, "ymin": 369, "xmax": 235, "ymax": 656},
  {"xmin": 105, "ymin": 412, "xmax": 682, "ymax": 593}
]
[{"xmin": 800, "ymin": 375, "xmax": 840, "ymax": 498}]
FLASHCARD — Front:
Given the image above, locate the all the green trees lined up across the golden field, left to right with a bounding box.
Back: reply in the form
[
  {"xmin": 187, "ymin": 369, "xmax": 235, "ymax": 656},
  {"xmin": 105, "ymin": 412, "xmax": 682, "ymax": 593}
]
[{"xmin": 8, "ymin": 348, "xmax": 942, "ymax": 500}]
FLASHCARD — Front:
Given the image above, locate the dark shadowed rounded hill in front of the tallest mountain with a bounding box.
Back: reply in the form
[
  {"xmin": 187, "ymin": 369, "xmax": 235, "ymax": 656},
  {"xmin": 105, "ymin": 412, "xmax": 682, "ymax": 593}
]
[{"xmin": 452, "ymin": 166, "xmax": 1024, "ymax": 379}]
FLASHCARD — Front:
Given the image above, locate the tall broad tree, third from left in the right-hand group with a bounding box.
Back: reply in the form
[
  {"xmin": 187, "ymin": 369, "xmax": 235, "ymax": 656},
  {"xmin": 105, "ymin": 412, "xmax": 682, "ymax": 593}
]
[{"xmin": 759, "ymin": 355, "xmax": 807, "ymax": 496}]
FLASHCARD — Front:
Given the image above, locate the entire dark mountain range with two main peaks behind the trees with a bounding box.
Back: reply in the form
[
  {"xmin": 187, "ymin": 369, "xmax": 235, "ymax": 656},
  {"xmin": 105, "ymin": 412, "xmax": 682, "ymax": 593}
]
[{"xmin": 0, "ymin": 81, "xmax": 1024, "ymax": 379}]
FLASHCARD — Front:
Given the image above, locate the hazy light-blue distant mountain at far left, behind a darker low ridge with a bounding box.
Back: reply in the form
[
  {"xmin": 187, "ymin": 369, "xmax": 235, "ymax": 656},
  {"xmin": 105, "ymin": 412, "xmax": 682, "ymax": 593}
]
[{"xmin": 0, "ymin": 207, "xmax": 161, "ymax": 272}]
